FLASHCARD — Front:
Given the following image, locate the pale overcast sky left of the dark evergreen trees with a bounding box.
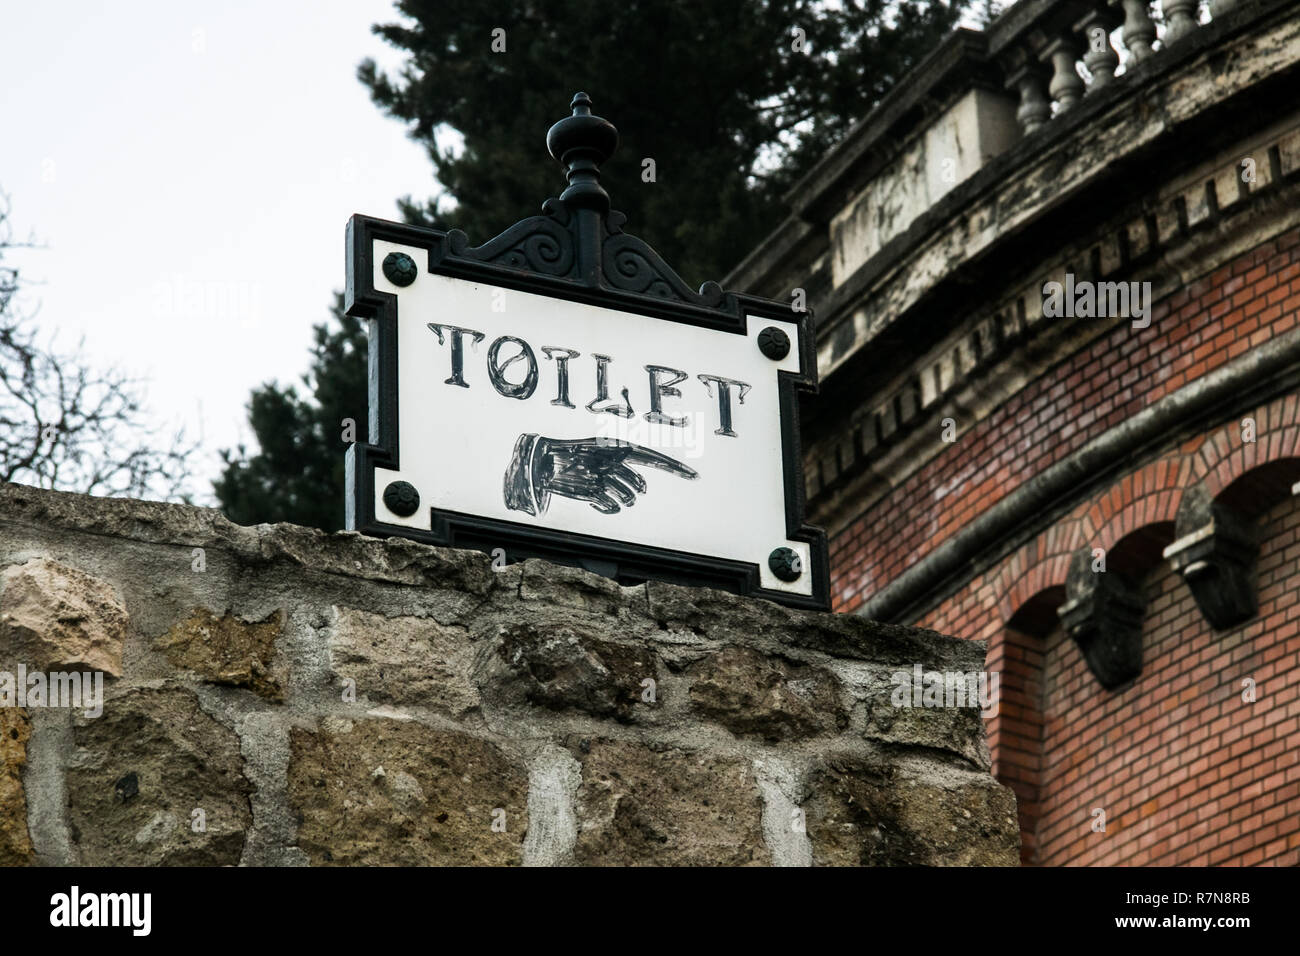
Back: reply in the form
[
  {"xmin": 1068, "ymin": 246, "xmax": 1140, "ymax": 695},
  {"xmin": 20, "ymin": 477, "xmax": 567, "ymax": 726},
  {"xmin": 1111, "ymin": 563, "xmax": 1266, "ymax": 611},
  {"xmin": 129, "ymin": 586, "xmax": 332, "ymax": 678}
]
[{"xmin": 0, "ymin": 0, "xmax": 439, "ymax": 503}]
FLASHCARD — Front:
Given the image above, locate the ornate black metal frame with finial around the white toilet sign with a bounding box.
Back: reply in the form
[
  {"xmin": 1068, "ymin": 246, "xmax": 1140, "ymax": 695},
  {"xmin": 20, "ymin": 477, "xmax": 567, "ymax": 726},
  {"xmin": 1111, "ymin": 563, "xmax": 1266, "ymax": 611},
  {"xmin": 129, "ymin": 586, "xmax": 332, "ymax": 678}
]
[{"xmin": 346, "ymin": 94, "xmax": 829, "ymax": 610}]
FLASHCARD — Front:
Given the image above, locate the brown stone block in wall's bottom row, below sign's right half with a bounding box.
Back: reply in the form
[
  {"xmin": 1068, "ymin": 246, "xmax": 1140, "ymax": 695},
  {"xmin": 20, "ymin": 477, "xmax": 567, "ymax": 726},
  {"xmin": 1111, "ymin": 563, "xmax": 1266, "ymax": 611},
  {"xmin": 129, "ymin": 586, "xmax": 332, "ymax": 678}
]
[{"xmin": 575, "ymin": 740, "xmax": 770, "ymax": 866}]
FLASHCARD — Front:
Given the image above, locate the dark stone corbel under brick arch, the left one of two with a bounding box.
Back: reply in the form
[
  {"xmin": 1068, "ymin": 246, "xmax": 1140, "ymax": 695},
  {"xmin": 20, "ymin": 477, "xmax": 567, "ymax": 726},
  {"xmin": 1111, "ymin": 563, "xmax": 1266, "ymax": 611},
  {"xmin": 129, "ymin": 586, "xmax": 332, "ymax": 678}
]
[{"xmin": 1057, "ymin": 549, "xmax": 1147, "ymax": 691}]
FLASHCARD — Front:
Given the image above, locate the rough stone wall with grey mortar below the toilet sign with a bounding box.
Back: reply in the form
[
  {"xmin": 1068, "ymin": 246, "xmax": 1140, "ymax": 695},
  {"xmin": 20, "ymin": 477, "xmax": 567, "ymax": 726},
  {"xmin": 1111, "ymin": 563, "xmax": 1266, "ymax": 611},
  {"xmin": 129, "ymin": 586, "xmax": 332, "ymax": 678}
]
[{"xmin": 0, "ymin": 485, "xmax": 1019, "ymax": 865}]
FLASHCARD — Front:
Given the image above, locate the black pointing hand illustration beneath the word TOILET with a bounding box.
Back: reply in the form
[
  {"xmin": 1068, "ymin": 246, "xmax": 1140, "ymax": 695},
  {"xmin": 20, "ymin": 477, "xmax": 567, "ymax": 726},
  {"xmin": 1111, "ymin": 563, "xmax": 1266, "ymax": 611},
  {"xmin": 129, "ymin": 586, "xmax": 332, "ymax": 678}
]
[{"xmin": 504, "ymin": 434, "xmax": 699, "ymax": 515}]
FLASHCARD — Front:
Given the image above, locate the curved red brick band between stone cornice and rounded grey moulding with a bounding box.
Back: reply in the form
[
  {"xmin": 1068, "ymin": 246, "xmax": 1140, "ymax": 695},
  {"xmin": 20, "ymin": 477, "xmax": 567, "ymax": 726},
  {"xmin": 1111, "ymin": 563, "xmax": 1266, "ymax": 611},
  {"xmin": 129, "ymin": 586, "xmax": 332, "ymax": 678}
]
[{"xmin": 831, "ymin": 229, "xmax": 1300, "ymax": 611}]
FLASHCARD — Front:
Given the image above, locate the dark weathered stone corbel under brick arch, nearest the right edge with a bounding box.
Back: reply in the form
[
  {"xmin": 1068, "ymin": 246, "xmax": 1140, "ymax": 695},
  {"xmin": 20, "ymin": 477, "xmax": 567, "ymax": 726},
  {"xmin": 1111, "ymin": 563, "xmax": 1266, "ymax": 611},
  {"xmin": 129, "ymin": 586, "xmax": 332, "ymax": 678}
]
[{"xmin": 1165, "ymin": 485, "xmax": 1260, "ymax": 631}]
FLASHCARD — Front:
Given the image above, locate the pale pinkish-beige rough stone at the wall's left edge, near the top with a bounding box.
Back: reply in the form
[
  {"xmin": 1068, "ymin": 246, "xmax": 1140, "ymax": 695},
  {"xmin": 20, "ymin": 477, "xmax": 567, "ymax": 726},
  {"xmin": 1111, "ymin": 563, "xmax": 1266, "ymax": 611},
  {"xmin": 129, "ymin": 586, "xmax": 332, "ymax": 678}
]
[{"xmin": 0, "ymin": 558, "xmax": 129, "ymax": 676}]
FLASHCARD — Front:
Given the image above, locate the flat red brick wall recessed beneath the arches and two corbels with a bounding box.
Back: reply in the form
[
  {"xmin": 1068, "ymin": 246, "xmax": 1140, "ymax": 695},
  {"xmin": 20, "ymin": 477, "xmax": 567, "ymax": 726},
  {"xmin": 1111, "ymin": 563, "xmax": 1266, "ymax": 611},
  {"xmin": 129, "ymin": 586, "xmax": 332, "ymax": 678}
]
[{"xmin": 1029, "ymin": 498, "xmax": 1300, "ymax": 866}]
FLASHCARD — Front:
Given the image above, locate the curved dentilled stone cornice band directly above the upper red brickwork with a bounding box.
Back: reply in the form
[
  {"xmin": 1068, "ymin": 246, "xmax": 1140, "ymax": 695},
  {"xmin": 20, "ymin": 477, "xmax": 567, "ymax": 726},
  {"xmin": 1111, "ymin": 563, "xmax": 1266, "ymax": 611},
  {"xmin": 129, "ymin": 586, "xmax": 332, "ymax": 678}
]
[{"xmin": 806, "ymin": 119, "xmax": 1300, "ymax": 522}]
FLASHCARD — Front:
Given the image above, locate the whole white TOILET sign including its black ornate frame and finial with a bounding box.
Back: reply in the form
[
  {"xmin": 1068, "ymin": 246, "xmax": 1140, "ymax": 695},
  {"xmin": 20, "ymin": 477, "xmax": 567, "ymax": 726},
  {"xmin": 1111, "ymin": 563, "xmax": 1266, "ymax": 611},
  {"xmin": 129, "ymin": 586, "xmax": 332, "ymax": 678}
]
[{"xmin": 347, "ymin": 94, "xmax": 828, "ymax": 607}]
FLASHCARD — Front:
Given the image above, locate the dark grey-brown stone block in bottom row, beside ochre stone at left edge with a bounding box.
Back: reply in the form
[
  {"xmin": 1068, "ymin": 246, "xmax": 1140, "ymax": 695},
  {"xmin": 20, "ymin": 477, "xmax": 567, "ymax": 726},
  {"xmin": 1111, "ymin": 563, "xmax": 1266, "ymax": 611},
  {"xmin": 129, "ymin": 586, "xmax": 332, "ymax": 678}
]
[{"xmin": 68, "ymin": 687, "xmax": 252, "ymax": 866}]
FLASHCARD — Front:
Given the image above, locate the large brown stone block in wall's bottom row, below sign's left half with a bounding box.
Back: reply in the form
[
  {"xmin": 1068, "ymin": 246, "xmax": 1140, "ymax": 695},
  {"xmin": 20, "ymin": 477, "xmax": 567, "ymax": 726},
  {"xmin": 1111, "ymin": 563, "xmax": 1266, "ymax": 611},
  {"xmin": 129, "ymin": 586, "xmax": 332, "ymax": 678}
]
[{"xmin": 289, "ymin": 718, "xmax": 528, "ymax": 866}]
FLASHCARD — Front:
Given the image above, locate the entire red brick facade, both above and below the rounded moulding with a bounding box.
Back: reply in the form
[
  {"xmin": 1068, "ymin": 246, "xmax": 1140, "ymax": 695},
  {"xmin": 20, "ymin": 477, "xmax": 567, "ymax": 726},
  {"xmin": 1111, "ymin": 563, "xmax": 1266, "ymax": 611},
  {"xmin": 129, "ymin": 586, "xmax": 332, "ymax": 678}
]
[{"xmin": 831, "ymin": 230, "xmax": 1300, "ymax": 865}]
